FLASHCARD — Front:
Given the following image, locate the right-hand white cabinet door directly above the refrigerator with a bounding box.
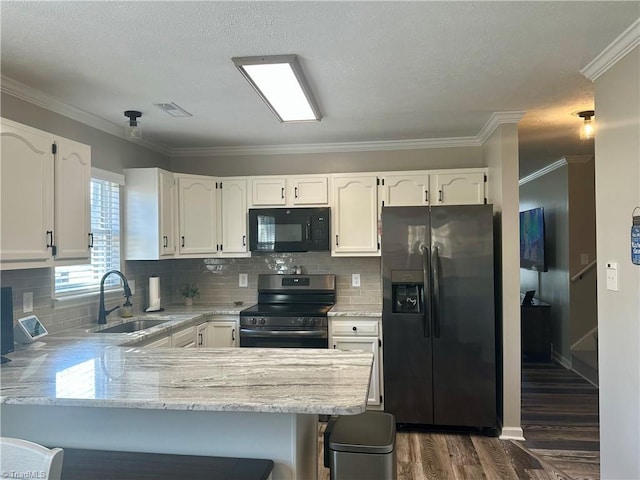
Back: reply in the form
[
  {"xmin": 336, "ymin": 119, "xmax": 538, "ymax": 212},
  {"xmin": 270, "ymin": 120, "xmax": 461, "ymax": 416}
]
[{"xmin": 431, "ymin": 172, "xmax": 486, "ymax": 205}]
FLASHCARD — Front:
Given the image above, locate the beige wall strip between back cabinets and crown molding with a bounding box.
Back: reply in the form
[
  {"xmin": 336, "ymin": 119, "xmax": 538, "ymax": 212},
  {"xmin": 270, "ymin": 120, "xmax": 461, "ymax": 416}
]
[{"xmin": 171, "ymin": 147, "xmax": 482, "ymax": 177}]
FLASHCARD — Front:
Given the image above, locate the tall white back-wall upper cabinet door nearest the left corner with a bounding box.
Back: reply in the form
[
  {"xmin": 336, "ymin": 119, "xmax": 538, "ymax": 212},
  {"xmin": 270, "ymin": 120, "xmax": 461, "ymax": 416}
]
[{"xmin": 176, "ymin": 174, "xmax": 218, "ymax": 256}]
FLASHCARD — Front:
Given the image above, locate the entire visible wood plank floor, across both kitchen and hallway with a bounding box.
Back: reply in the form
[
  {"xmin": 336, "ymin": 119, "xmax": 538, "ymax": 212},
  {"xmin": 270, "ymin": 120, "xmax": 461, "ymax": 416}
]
[{"xmin": 318, "ymin": 365, "xmax": 600, "ymax": 480}]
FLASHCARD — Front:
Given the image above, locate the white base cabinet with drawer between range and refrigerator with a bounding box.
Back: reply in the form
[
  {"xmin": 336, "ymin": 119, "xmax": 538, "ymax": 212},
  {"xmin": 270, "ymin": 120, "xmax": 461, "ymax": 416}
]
[{"xmin": 329, "ymin": 317, "xmax": 383, "ymax": 409}]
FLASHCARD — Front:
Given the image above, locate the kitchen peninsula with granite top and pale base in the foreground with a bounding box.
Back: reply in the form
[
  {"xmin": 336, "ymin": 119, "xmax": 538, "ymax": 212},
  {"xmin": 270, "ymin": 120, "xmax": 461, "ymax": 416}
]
[{"xmin": 0, "ymin": 316, "xmax": 373, "ymax": 480}]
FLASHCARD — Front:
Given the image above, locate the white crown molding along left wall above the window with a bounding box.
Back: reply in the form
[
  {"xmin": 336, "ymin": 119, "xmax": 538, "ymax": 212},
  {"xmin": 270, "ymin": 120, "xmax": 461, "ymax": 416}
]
[{"xmin": 0, "ymin": 75, "xmax": 171, "ymax": 156}]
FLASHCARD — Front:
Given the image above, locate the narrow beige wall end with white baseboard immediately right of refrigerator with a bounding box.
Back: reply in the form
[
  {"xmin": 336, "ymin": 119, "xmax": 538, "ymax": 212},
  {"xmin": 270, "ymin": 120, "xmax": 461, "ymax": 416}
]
[{"xmin": 482, "ymin": 124, "xmax": 522, "ymax": 438}]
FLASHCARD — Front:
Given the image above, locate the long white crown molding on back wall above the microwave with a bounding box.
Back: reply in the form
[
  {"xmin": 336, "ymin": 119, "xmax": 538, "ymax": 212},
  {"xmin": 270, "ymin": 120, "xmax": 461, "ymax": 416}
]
[{"xmin": 171, "ymin": 137, "xmax": 480, "ymax": 157}]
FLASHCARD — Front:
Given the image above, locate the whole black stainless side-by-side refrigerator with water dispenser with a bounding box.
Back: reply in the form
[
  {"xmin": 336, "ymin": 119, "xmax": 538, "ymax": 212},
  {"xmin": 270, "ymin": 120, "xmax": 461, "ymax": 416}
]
[{"xmin": 382, "ymin": 205, "xmax": 497, "ymax": 433}]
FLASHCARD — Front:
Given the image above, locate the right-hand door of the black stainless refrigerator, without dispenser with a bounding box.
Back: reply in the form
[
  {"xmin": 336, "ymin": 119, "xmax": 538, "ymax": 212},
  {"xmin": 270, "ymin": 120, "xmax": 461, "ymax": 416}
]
[{"xmin": 430, "ymin": 205, "xmax": 497, "ymax": 428}]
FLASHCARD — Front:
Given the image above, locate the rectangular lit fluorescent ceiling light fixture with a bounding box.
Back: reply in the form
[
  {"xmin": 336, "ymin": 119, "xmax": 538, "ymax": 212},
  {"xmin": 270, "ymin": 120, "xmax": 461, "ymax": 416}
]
[{"xmin": 231, "ymin": 55, "xmax": 322, "ymax": 122}]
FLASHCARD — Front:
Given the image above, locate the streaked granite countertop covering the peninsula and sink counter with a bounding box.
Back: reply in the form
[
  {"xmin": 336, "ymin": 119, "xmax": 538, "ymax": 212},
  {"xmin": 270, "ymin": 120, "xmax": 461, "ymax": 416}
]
[{"xmin": 0, "ymin": 306, "xmax": 373, "ymax": 415}]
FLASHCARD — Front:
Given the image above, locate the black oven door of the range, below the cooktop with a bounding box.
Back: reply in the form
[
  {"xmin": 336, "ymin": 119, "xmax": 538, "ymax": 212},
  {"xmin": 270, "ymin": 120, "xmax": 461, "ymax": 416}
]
[{"xmin": 240, "ymin": 326, "xmax": 329, "ymax": 348}]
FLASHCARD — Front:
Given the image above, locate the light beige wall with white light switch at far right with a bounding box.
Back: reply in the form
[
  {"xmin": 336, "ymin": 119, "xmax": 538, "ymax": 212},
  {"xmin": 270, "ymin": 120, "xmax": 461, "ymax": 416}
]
[{"xmin": 595, "ymin": 47, "xmax": 640, "ymax": 480}]
